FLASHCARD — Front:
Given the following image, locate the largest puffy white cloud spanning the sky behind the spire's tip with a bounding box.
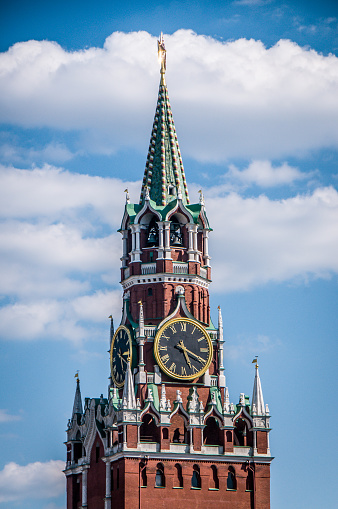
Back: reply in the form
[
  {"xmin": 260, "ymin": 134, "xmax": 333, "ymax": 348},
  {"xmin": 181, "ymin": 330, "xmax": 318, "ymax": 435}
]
[{"xmin": 0, "ymin": 30, "xmax": 338, "ymax": 161}]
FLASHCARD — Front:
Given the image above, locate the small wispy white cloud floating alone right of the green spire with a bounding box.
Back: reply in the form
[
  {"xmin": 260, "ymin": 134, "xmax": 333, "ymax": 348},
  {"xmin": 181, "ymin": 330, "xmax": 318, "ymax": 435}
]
[{"xmin": 224, "ymin": 161, "xmax": 313, "ymax": 187}]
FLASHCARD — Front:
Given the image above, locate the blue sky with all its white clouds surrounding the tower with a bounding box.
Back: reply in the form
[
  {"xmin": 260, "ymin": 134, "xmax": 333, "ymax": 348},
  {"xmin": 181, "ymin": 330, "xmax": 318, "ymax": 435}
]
[{"xmin": 0, "ymin": 0, "xmax": 338, "ymax": 509}]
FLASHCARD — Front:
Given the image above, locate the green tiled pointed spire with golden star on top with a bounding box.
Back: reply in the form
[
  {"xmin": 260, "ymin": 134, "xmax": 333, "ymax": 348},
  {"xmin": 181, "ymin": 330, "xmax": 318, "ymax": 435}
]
[{"xmin": 140, "ymin": 34, "xmax": 189, "ymax": 206}]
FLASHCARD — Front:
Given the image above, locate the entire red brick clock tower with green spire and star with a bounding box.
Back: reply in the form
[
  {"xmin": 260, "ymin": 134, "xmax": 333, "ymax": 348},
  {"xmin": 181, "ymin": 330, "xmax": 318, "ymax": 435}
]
[{"xmin": 65, "ymin": 35, "xmax": 272, "ymax": 509}]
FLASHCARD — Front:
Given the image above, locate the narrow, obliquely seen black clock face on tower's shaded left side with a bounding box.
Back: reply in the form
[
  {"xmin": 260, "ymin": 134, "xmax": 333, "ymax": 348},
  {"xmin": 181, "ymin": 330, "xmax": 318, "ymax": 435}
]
[{"xmin": 110, "ymin": 325, "xmax": 132, "ymax": 387}]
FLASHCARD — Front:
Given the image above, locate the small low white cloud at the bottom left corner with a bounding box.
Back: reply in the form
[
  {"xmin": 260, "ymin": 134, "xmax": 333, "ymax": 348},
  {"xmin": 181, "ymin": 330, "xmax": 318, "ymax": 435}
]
[{"xmin": 0, "ymin": 460, "xmax": 65, "ymax": 503}]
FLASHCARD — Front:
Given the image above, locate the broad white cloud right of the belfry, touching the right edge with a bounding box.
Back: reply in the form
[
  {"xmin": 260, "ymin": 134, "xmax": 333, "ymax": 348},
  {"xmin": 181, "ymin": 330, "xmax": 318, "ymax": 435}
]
[{"xmin": 206, "ymin": 187, "xmax": 338, "ymax": 292}]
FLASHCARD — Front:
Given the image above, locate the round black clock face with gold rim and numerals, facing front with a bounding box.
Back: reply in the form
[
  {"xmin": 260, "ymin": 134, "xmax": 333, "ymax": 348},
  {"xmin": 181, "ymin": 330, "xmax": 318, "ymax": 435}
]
[{"xmin": 154, "ymin": 318, "xmax": 212, "ymax": 380}]
